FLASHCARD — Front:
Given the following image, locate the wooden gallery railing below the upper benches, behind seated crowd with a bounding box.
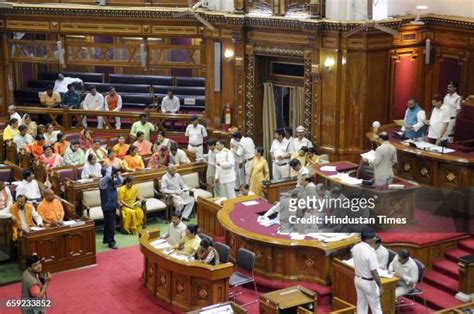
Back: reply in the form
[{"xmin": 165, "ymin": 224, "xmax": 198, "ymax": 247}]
[{"xmin": 16, "ymin": 106, "xmax": 206, "ymax": 130}]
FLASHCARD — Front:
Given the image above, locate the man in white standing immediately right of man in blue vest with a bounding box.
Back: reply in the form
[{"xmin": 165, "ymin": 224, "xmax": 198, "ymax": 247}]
[{"xmin": 428, "ymin": 94, "xmax": 451, "ymax": 145}]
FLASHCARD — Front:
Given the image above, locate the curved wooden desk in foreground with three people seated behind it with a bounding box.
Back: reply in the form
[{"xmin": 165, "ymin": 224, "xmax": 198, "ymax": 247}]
[{"xmin": 139, "ymin": 231, "xmax": 234, "ymax": 311}]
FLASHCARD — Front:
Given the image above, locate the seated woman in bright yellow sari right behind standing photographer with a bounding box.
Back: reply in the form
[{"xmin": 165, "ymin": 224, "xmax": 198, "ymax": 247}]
[{"xmin": 118, "ymin": 177, "xmax": 145, "ymax": 234}]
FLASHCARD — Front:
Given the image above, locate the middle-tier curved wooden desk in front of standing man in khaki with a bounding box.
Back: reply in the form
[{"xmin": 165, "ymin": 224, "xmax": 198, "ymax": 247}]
[{"xmin": 316, "ymin": 161, "xmax": 420, "ymax": 223}]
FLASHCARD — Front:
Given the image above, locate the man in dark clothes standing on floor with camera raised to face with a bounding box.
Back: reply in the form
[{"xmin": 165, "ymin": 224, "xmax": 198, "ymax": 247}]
[{"xmin": 99, "ymin": 167, "xmax": 123, "ymax": 249}]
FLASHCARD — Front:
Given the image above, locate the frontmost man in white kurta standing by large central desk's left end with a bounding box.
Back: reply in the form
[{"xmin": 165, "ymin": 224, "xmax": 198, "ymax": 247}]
[{"xmin": 215, "ymin": 141, "xmax": 236, "ymax": 199}]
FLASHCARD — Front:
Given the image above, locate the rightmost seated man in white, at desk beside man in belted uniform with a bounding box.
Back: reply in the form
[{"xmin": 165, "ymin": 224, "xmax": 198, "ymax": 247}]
[{"xmin": 388, "ymin": 249, "xmax": 418, "ymax": 298}]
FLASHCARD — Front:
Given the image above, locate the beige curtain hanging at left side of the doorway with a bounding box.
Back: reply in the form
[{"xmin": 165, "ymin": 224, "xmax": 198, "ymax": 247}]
[{"xmin": 263, "ymin": 83, "xmax": 276, "ymax": 160}]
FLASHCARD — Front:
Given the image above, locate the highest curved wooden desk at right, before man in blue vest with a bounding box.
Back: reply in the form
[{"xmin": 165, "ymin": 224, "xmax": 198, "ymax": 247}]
[{"xmin": 366, "ymin": 124, "xmax": 474, "ymax": 188}]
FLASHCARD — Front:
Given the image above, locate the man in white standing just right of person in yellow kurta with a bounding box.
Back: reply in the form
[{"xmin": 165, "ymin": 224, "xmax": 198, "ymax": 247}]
[{"xmin": 270, "ymin": 129, "xmax": 291, "ymax": 180}]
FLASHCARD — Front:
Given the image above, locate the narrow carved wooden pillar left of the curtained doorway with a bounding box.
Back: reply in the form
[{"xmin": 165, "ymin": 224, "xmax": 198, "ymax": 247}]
[{"xmin": 245, "ymin": 45, "xmax": 255, "ymax": 137}]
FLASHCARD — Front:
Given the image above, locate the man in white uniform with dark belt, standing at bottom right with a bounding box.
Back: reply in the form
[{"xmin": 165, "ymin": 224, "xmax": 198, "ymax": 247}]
[{"xmin": 351, "ymin": 229, "xmax": 383, "ymax": 314}]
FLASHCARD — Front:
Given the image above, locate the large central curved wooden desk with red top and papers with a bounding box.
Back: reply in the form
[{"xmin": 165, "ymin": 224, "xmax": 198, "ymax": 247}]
[{"xmin": 217, "ymin": 196, "xmax": 359, "ymax": 285}]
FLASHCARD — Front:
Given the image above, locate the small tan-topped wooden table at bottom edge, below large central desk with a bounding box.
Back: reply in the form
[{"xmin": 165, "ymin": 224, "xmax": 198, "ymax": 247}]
[{"xmin": 260, "ymin": 286, "xmax": 317, "ymax": 314}]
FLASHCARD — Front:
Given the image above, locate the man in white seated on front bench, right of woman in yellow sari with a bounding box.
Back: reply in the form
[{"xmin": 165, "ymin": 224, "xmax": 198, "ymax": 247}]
[{"xmin": 161, "ymin": 165, "xmax": 195, "ymax": 221}]
